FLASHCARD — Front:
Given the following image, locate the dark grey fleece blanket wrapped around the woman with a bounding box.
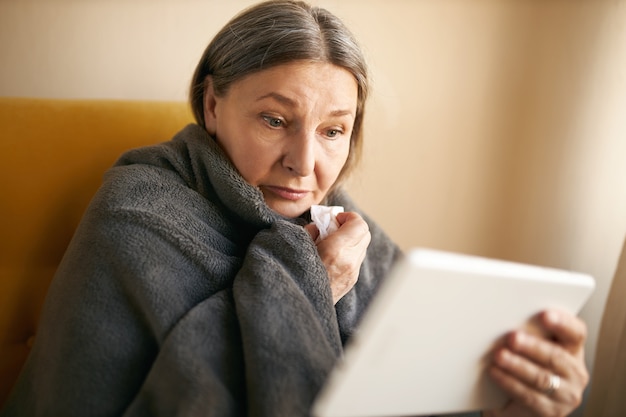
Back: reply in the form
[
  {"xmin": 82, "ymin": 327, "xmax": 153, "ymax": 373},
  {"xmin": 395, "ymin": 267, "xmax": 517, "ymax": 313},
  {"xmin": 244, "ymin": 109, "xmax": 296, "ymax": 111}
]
[{"xmin": 2, "ymin": 125, "xmax": 399, "ymax": 417}]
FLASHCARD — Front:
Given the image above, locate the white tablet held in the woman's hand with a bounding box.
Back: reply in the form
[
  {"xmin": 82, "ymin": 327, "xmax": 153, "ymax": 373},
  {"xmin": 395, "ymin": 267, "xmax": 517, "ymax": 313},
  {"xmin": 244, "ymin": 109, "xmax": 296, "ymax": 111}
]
[{"xmin": 313, "ymin": 249, "xmax": 595, "ymax": 417}]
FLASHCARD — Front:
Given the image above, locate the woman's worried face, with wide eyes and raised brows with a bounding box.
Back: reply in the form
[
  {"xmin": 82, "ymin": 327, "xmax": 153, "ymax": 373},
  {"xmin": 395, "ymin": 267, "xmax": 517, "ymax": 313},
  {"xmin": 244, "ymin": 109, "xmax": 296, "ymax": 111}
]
[{"xmin": 204, "ymin": 61, "xmax": 358, "ymax": 217}]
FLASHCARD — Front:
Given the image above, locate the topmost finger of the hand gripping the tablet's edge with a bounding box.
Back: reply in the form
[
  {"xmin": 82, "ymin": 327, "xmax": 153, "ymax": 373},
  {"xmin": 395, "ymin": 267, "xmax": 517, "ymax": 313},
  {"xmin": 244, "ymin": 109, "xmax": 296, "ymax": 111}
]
[{"xmin": 539, "ymin": 309, "xmax": 587, "ymax": 353}]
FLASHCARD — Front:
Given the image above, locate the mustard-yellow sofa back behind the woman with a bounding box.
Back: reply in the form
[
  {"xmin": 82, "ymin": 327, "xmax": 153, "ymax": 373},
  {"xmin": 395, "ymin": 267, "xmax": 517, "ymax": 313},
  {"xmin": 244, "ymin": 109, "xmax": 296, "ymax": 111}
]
[{"xmin": 0, "ymin": 98, "xmax": 192, "ymax": 408}]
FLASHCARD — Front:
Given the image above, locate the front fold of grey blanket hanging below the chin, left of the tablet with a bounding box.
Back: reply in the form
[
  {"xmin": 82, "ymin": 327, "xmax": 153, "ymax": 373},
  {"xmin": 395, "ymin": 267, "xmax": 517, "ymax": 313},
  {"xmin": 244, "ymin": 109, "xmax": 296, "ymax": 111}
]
[{"xmin": 233, "ymin": 221, "xmax": 341, "ymax": 416}]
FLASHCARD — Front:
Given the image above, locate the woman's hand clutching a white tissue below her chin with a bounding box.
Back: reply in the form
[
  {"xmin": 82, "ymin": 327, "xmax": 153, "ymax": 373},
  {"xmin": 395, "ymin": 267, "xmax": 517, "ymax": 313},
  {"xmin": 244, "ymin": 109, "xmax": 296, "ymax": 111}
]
[{"xmin": 305, "ymin": 212, "xmax": 371, "ymax": 304}]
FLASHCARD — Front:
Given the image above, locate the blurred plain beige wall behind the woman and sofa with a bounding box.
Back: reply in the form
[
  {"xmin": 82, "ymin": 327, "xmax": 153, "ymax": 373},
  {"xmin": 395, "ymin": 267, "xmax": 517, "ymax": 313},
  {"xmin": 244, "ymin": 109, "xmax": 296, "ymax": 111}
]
[{"xmin": 0, "ymin": 0, "xmax": 626, "ymax": 414}]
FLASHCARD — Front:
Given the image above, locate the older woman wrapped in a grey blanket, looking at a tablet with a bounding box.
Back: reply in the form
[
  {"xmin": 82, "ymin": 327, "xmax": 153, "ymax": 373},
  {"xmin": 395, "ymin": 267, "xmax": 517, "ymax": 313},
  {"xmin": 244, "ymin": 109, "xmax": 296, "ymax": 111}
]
[{"xmin": 3, "ymin": 1, "xmax": 586, "ymax": 416}]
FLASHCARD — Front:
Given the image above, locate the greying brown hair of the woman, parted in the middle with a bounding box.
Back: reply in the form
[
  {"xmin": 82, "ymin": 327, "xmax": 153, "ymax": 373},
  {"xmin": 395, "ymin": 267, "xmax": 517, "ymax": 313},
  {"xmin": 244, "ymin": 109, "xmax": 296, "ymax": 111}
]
[{"xmin": 189, "ymin": 0, "xmax": 368, "ymax": 182}]
